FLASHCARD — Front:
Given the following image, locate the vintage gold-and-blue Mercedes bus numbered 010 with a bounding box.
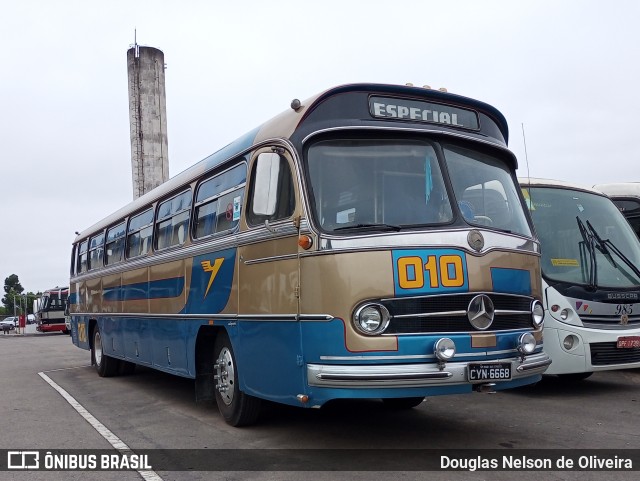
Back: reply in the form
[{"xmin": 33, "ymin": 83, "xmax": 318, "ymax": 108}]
[{"xmin": 70, "ymin": 84, "xmax": 550, "ymax": 425}]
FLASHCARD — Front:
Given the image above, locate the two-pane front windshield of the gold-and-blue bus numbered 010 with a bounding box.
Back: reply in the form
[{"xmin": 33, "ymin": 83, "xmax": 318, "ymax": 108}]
[{"xmin": 306, "ymin": 139, "xmax": 531, "ymax": 236}]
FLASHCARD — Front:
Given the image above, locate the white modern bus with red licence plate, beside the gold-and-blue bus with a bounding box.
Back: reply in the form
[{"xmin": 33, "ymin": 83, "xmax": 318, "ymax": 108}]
[{"xmin": 520, "ymin": 178, "xmax": 640, "ymax": 380}]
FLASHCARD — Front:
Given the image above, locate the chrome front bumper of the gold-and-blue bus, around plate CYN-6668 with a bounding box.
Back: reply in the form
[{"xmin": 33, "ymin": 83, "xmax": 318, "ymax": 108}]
[{"xmin": 307, "ymin": 351, "xmax": 551, "ymax": 388}]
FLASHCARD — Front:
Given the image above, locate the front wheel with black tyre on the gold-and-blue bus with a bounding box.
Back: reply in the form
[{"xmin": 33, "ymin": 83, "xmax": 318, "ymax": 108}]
[{"xmin": 213, "ymin": 332, "xmax": 260, "ymax": 427}]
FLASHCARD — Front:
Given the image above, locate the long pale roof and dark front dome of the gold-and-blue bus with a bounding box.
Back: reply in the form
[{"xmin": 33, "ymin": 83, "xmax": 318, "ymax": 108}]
[{"xmin": 74, "ymin": 83, "xmax": 517, "ymax": 243}]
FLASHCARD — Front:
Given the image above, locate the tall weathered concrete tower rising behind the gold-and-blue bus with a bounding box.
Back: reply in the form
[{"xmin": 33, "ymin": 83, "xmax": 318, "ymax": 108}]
[{"xmin": 127, "ymin": 43, "xmax": 169, "ymax": 199}]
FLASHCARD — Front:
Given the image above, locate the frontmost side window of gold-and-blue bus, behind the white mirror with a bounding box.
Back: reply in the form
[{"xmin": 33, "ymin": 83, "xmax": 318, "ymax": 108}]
[{"xmin": 247, "ymin": 152, "xmax": 295, "ymax": 225}]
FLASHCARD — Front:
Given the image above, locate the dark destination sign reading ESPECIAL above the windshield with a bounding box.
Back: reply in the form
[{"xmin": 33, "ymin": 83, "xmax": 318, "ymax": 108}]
[{"xmin": 369, "ymin": 97, "xmax": 480, "ymax": 130}]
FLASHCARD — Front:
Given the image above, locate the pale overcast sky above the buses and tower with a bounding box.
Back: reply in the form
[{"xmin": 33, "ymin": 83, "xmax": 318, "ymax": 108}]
[{"xmin": 0, "ymin": 0, "xmax": 640, "ymax": 292}]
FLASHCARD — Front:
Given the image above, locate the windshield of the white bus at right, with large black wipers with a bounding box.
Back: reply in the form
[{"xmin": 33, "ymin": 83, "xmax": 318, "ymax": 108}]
[{"xmin": 525, "ymin": 187, "xmax": 640, "ymax": 289}]
